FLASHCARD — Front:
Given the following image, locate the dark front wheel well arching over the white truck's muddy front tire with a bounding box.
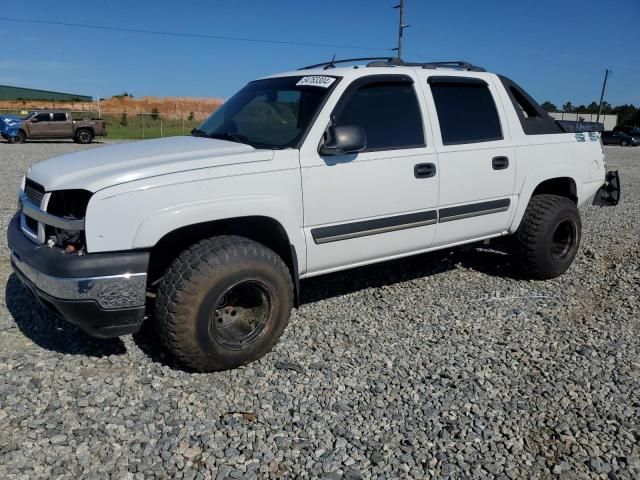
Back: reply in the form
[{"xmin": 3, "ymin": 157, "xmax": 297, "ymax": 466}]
[{"xmin": 148, "ymin": 216, "xmax": 299, "ymax": 306}]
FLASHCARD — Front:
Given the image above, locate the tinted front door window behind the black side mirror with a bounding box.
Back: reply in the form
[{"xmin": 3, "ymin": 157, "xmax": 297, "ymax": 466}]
[{"xmin": 334, "ymin": 81, "xmax": 424, "ymax": 151}]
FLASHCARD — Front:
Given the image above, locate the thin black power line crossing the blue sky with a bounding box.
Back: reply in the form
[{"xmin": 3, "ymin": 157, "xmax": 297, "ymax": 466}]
[{"xmin": 0, "ymin": 17, "xmax": 393, "ymax": 51}]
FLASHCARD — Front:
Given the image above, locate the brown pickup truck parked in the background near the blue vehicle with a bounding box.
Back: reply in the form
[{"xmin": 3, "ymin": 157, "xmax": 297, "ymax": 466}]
[{"xmin": 13, "ymin": 110, "xmax": 107, "ymax": 143}]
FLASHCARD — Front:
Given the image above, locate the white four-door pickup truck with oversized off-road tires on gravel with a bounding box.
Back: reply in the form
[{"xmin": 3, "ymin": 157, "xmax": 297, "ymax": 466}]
[{"xmin": 8, "ymin": 59, "xmax": 619, "ymax": 371}]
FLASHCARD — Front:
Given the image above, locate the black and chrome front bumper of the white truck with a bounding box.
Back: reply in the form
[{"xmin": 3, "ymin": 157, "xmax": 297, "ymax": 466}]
[{"xmin": 7, "ymin": 215, "xmax": 149, "ymax": 338}]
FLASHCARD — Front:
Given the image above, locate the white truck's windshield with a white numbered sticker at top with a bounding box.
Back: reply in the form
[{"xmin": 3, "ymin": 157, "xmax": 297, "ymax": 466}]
[{"xmin": 193, "ymin": 77, "xmax": 337, "ymax": 149}]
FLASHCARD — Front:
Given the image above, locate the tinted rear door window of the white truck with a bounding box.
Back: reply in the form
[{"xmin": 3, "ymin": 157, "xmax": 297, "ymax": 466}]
[{"xmin": 429, "ymin": 77, "xmax": 503, "ymax": 145}]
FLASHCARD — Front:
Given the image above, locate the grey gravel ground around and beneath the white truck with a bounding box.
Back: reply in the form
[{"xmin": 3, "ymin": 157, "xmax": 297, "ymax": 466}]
[{"xmin": 0, "ymin": 143, "xmax": 640, "ymax": 480}]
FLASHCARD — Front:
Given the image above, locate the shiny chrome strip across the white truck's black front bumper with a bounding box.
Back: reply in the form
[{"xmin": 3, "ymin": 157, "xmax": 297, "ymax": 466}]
[{"xmin": 11, "ymin": 252, "xmax": 147, "ymax": 309}]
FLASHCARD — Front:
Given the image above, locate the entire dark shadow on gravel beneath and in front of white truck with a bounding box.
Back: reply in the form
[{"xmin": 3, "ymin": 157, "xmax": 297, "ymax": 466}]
[{"xmin": 5, "ymin": 244, "xmax": 519, "ymax": 372}]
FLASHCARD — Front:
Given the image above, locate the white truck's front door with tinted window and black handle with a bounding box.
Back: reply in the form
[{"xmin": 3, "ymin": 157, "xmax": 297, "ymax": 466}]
[{"xmin": 300, "ymin": 75, "xmax": 438, "ymax": 275}]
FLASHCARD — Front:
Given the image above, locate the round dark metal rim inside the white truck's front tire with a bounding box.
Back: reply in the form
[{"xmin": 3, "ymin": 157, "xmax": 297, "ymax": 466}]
[{"xmin": 209, "ymin": 280, "xmax": 273, "ymax": 350}]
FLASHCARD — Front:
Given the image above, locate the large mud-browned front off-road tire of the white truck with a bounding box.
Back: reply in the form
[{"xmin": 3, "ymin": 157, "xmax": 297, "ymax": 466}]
[{"xmin": 155, "ymin": 236, "xmax": 293, "ymax": 372}]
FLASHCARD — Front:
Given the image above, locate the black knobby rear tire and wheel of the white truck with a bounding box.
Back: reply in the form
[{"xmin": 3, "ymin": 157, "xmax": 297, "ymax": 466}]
[{"xmin": 514, "ymin": 194, "xmax": 582, "ymax": 280}]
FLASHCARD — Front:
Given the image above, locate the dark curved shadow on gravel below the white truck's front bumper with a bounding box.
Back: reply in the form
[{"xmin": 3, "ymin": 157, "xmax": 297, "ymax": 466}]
[{"xmin": 5, "ymin": 274, "xmax": 126, "ymax": 357}]
